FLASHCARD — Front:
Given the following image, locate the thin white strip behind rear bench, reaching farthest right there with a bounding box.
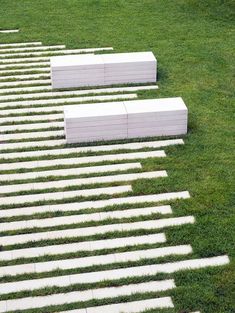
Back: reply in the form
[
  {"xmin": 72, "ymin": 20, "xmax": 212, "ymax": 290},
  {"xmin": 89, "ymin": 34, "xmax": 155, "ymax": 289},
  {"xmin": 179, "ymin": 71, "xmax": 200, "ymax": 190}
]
[{"xmin": 0, "ymin": 47, "xmax": 113, "ymax": 58}]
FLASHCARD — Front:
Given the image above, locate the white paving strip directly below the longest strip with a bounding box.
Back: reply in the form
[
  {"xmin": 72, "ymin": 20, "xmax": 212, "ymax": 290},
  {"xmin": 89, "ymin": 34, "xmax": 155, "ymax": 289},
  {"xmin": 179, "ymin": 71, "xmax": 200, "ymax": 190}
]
[{"xmin": 0, "ymin": 279, "xmax": 173, "ymax": 313}]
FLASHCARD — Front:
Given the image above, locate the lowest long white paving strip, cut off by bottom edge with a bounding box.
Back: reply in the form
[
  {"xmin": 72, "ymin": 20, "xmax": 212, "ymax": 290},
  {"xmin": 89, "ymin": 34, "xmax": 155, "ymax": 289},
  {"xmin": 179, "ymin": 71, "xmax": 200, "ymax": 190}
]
[{"xmin": 58, "ymin": 297, "xmax": 174, "ymax": 313}]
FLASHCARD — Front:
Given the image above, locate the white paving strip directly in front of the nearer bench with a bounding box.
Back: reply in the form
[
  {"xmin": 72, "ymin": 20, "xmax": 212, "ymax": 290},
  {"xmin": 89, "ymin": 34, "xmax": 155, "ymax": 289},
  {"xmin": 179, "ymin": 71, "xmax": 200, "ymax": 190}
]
[{"xmin": 0, "ymin": 138, "xmax": 184, "ymax": 160}]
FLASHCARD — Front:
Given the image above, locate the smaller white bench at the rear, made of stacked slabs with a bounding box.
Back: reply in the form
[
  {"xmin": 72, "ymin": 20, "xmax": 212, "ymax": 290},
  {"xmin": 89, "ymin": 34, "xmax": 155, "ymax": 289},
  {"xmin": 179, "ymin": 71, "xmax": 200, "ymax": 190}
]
[{"xmin": 51, "ymin": 52, "xmax": 157, "ymax": 89}]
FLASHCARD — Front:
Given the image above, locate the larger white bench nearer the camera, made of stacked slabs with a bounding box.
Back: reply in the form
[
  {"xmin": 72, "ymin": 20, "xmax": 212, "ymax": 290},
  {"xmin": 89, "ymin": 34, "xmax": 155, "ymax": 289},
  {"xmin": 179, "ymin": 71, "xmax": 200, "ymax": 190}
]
[{"xmin": 64, "ymin": 98, "xmax": 188, "ymax": 143}]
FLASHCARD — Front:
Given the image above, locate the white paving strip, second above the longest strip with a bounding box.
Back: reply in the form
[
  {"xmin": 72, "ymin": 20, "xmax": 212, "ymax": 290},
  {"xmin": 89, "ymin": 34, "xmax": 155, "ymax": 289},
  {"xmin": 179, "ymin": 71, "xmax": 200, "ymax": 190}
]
[{"xmin": 0, "ymin": 233, "xmax": 166, "ymax": 261}]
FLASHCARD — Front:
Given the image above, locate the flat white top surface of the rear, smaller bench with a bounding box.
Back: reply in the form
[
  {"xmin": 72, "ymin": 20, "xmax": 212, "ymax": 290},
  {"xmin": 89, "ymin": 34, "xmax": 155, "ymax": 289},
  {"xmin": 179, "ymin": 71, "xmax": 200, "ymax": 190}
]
[{"xmin": 50, "ymin": 52, "xmax": 156, "ymax": 70}]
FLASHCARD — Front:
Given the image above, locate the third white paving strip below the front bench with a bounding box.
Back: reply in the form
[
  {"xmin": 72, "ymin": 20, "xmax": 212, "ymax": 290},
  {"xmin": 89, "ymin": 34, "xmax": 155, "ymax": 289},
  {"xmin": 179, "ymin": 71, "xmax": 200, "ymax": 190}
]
[{"xmin": 0, "ymin": 162, "xmax": 142, "ymax": 182}]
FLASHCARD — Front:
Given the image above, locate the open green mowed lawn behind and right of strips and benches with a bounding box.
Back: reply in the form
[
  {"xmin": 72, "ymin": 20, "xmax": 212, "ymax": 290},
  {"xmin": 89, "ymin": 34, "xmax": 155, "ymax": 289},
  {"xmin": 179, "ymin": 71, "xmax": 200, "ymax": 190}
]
[{"xmin": 0, "ymin": 0, "xmax": 235, "ymax": 313}]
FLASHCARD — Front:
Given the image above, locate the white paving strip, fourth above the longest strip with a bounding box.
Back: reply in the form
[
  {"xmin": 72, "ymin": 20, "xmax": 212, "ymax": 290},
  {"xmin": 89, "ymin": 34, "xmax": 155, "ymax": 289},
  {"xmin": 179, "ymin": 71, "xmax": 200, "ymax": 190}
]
[{"xmin": 0, "ymin": 205, "xmax": 172, "ymax": 230}]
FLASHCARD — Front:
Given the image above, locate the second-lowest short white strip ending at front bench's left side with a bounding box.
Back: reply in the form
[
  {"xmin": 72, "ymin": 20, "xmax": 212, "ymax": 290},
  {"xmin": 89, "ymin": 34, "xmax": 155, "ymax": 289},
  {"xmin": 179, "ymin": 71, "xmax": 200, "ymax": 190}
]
[{"xmin": 0, "ymin": 130, "xmax": 65, "ymax": 141}]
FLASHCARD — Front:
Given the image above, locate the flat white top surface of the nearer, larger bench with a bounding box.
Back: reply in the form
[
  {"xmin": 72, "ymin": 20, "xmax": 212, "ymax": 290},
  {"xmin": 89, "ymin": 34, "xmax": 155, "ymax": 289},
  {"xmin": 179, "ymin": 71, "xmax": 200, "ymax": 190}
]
[{"xmin": 64, "ymin": 97, "xmax": 187, "ymax": 119}]
